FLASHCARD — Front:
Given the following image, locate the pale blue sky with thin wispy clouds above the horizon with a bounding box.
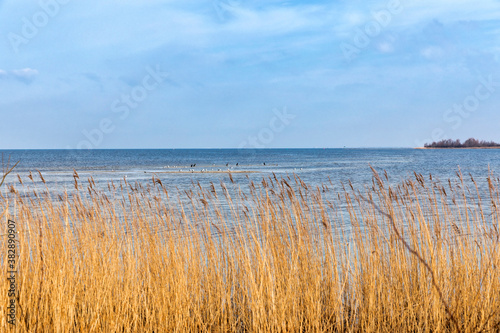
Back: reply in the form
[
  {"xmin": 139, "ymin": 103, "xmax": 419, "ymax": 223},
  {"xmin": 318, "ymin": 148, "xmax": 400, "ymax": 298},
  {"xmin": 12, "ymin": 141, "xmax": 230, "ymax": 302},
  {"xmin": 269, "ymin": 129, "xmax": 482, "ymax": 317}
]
[{"xmin": 0, "ymin": 0, "xmax": 500, "ymax": 149}]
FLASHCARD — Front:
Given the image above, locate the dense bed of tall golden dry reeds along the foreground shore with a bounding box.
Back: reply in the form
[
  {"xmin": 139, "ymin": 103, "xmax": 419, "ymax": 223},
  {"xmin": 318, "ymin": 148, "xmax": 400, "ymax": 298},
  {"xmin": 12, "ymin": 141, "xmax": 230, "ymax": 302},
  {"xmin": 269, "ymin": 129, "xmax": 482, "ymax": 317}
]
[{"xmin": 0, "ymin": 171, "xmax": 500, "ymax": 332}]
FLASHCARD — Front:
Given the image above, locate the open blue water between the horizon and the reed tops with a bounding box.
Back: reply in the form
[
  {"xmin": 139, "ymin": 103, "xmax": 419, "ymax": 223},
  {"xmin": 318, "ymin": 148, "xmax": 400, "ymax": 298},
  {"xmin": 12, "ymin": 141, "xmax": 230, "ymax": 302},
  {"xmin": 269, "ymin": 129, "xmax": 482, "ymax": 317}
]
[{"xmin": 0, "ymin": 149, "xmax": 500, "ymax": 191}]
